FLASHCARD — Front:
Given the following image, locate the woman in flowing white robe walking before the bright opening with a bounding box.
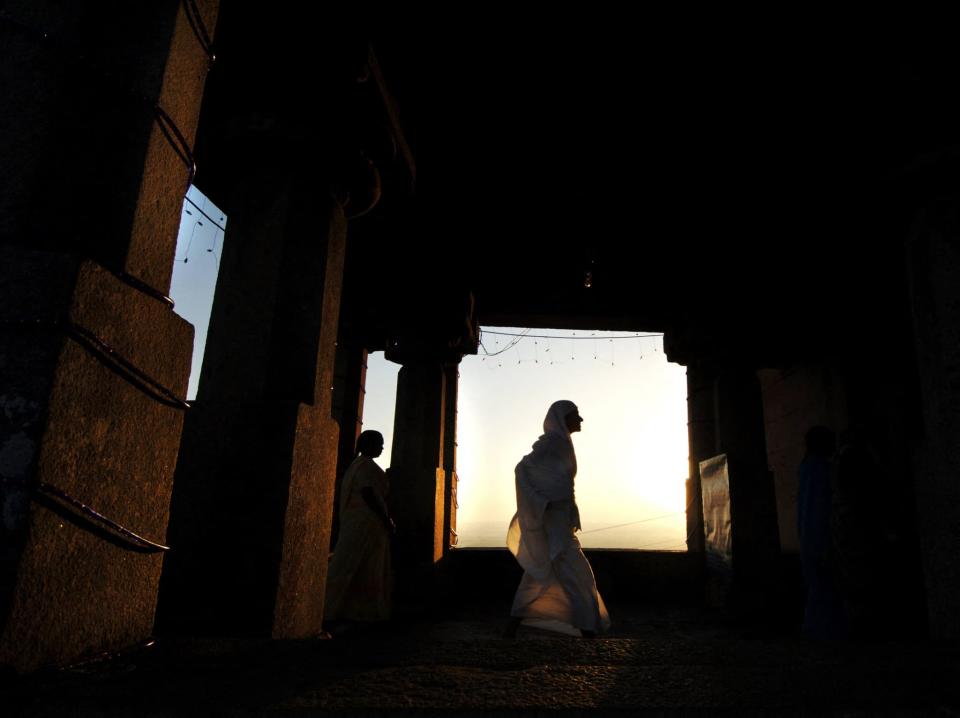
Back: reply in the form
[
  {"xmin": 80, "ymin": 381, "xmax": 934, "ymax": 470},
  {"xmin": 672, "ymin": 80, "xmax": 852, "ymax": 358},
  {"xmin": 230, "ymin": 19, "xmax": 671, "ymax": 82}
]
[{"xmin": 506, "ymin": 401, "xmax": 610, "ymax": 636}]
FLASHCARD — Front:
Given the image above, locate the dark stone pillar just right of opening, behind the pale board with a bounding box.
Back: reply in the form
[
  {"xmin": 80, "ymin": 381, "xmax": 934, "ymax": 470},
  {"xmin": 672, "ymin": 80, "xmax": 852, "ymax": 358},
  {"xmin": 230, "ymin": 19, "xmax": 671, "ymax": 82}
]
[{"xmin": 714, "ymin": 366, "xmax": 780, "ymax": 607}]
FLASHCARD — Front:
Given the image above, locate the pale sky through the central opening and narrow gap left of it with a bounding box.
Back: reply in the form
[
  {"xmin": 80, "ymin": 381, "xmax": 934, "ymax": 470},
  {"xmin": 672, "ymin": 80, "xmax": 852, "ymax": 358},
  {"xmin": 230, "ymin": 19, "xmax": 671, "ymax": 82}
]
[{"xmin": 364, "ymin": 327, "xmax": 688, "ymax": 549}]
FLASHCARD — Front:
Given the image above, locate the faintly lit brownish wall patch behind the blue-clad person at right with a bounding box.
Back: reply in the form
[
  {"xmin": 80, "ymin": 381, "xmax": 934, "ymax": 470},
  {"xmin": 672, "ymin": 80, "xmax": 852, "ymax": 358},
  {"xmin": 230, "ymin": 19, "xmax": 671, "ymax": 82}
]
[{"xmin": 758, "ymin": 365, "xmax": 847, "ymax": 553}]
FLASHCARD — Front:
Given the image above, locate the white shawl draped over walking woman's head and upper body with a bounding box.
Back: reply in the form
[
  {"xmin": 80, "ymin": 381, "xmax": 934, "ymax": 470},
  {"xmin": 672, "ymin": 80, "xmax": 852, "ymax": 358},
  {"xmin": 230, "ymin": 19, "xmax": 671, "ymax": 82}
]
[{"xmin": 507, "ymin": 401, "xmax": 580, "ymax": 580}]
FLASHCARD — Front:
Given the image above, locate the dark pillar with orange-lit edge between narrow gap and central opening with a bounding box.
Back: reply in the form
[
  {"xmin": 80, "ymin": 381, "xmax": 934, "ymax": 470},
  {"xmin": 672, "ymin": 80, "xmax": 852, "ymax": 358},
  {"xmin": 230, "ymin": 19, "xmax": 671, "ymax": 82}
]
[{"xmin": 390, "ymin": 358, "xmax": 447, "ymax": 604}]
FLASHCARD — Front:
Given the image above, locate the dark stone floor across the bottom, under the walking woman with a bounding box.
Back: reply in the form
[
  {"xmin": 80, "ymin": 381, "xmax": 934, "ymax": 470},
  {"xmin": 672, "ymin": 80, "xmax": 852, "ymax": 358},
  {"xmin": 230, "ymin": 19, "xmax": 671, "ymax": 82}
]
[{"xmin": 7, "ymin": 605, "xmax": 960, "ymax": 718}]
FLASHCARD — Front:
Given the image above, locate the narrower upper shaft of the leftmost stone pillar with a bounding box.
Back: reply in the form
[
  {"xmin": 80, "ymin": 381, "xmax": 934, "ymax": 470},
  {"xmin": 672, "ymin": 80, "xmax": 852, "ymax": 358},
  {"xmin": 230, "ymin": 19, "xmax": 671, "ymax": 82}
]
[{"xmin": 0, "ymin": 0, "xmax": 218, "ymax": 291}]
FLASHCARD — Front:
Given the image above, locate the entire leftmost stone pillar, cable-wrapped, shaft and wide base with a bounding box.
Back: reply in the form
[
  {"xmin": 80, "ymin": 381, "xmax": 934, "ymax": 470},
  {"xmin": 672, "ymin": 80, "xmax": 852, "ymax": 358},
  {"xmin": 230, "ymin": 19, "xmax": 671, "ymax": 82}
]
[{"xmin": 0, "ymin": 0, "xmax": 218, "ymax": 670}]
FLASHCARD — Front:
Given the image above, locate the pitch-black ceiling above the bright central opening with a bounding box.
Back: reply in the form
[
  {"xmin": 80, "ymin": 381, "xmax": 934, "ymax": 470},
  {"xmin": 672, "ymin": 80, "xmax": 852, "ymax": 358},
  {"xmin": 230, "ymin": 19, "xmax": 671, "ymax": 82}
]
[{"xmin": 199, "ymin": 2, "xmax": 960, "ymax": 352}]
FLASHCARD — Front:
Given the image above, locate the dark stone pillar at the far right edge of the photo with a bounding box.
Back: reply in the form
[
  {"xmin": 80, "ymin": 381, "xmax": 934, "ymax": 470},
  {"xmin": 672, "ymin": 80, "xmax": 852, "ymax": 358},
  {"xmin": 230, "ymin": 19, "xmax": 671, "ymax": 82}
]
[{"xmin": 907, "ymin": 198, "xmax": 960, "ymax": 638}]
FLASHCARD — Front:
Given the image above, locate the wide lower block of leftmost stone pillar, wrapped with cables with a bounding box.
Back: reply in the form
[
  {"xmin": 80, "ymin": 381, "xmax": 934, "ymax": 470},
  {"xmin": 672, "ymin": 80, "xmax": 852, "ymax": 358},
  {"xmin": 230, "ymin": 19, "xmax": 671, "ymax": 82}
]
[{"xmin": 0, "ymin": 253, "xmax": 193, "ymax": 670}]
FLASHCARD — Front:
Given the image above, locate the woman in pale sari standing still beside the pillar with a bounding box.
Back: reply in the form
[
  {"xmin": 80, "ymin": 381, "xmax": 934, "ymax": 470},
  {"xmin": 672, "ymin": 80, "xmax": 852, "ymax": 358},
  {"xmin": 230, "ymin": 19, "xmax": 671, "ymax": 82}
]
[{"xmin": 324, "ymin": 431, "xmax": 394, "ymax": 622}]
